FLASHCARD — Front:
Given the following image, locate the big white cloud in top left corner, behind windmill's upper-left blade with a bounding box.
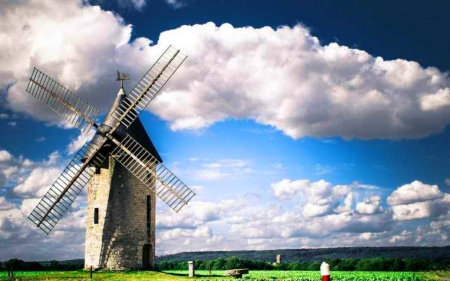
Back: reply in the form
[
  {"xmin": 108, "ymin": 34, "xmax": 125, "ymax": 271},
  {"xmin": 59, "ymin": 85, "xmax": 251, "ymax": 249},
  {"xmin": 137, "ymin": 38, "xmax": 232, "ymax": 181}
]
[{"xmin": 0, "ymin": 0, "xmax": 163, "ymax": 124}]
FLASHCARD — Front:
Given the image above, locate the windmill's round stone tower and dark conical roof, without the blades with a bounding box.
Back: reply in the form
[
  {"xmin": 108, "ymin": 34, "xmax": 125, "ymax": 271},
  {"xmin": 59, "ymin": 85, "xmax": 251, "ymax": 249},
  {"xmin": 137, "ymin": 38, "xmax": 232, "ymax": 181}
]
[{"xmin": 85, "ymin": 88, "xmax": 162, "ymax": 270}]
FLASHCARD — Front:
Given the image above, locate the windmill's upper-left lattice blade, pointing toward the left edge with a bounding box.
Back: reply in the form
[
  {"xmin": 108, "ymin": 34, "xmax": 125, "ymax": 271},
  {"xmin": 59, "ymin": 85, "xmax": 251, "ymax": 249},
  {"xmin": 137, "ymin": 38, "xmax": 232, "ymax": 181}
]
[{"xmin": 27, "ymin": 68, "xmax": 100, "ymax": 133}]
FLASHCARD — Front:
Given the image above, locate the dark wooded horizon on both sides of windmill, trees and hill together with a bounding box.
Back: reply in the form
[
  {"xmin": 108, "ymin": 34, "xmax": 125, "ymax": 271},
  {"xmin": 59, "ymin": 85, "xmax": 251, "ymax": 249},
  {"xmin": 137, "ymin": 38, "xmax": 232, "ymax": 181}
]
[{"xmin": 0, "ymin": 247, "xmax": 450, "ymax": 271}]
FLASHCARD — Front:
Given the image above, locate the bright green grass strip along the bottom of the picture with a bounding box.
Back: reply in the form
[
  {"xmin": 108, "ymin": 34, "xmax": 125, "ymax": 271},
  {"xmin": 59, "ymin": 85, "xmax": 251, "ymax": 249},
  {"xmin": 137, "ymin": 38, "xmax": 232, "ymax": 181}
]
[{"xmin": 0, "ymin": 270, "xmax": 450, "ymax": 281}]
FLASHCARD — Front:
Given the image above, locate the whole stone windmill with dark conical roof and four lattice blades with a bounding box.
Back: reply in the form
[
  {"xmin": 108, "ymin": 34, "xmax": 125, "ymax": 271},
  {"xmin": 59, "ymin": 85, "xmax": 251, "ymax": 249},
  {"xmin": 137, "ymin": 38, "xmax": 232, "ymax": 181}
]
[{"xmin": 26, "ymin": 46, "xmax": 195, "ymax": 269}]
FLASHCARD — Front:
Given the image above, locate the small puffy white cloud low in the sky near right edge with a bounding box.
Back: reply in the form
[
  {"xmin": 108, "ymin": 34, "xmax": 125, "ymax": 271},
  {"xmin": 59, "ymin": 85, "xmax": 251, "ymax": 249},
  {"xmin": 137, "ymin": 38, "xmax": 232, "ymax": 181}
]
[{"xmin": 387, "ymin": 181, "xmax": 443, "ymax": 205}]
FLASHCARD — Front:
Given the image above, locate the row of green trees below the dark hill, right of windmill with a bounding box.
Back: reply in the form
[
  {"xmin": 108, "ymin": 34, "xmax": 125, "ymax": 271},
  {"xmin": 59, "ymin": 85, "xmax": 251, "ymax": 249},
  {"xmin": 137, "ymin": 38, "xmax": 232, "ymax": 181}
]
[{"xmin": 157, "ymin": 257, "xmax": 450, "ymax": 271}]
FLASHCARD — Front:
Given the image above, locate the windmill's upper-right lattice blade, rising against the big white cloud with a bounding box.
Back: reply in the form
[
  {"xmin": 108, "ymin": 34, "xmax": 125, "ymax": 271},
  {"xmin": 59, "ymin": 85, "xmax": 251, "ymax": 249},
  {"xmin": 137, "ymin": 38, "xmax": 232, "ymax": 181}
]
[{"xmin": 113, "ymin": 46, "xmax": 187, "ymax": 128}]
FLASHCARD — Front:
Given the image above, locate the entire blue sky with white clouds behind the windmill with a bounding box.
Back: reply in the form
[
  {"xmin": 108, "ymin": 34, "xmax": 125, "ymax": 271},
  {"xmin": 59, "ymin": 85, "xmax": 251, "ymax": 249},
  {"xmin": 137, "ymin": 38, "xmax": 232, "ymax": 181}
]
[{"xmin": 0, "ymin": 0, "xmax": 450, "ymax": 260}]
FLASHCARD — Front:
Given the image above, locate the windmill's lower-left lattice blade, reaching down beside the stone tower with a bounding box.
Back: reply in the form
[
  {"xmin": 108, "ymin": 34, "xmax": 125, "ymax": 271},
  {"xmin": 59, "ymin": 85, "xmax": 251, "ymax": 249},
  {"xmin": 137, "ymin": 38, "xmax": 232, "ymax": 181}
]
[{"xmin": 28, "ymin": 138, "xmax": 106, "ymax": 234}]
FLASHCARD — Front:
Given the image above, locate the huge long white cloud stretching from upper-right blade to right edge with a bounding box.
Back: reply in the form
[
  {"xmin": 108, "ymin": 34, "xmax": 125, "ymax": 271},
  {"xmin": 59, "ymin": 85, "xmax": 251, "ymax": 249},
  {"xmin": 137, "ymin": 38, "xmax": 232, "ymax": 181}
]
[{"xmin": 151, "ymin": 23, "xmax": 450, "ymax": 139}]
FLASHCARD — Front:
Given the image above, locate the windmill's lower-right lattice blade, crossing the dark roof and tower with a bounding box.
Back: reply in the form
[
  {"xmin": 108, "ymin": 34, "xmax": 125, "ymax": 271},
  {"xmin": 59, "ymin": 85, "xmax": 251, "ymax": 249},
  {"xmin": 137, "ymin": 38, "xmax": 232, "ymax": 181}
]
[{"xmin": 112, "ymin": 135, "xmax": 195, "ymax": 212}]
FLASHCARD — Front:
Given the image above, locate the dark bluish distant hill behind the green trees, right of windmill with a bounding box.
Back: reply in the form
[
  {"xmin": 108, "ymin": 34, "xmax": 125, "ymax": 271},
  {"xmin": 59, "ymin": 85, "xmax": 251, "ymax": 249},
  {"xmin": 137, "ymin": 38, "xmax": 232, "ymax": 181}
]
[{"xmin": 156, "ymin": 246, "xmax": 450, "ymax": 262}]
